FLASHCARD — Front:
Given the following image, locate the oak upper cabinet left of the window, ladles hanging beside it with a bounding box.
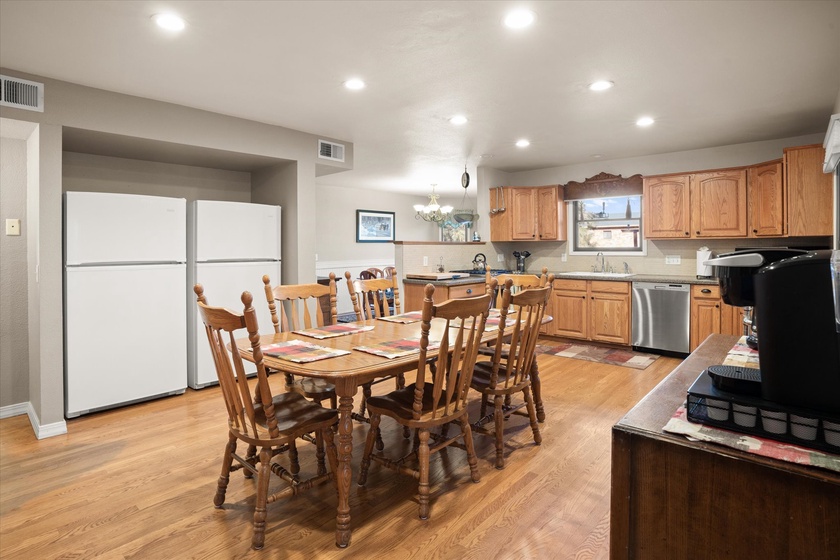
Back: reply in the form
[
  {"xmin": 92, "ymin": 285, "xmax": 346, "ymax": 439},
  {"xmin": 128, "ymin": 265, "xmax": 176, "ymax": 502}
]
[{"xmin": 490, "ymin": 185, "xmax": 566, "ymax": 241}]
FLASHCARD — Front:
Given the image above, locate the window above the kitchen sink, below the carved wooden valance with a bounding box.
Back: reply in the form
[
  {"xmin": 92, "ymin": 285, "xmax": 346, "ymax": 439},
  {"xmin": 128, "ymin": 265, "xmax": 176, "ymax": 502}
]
[{"xmin": 569, "ymin": 195, "xmax": 644, "ymax": 254}]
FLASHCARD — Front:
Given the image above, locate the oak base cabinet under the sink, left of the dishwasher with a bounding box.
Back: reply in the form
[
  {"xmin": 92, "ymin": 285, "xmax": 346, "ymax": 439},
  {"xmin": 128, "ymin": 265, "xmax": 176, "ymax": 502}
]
[{"xmin": 548, "ymin": 278, "xmax": 630, "ymax": 345}]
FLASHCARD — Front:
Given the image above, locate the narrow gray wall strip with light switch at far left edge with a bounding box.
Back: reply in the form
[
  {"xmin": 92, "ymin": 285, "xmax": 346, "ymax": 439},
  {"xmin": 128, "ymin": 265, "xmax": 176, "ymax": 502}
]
[{"xmin": 0, "ymin": 136, "xmax": 29, "ymax": 406}]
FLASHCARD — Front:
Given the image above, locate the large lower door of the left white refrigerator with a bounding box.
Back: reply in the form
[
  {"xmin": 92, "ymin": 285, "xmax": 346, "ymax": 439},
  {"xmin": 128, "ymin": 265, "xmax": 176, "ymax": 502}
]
[{"xmin": 64, "ymin": 264, "xmax": 187, "ymax": 418}]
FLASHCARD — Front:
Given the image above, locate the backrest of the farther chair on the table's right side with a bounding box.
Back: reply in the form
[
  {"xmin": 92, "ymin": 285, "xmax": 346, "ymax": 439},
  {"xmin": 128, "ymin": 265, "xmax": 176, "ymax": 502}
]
[{"xmin": 490, "ymin": 274, "xmax": 554, "ymax": 388}]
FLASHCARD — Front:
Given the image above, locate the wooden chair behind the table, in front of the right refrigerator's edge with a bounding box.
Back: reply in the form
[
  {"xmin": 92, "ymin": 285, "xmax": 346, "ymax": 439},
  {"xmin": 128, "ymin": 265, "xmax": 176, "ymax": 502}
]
[{"xmin": 263, "ymin": 272, "xmax": 338, "ymax": 408}]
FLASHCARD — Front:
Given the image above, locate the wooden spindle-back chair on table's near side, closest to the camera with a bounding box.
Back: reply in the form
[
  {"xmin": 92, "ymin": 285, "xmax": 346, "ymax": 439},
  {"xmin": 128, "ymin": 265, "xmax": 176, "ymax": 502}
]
[{"xmin": 359, "ymin": 284, "xmax": 491, "ymax": 519}]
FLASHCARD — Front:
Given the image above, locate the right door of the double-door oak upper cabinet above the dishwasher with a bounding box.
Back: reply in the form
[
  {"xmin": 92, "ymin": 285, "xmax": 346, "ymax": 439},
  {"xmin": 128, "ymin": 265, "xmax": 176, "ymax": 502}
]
[{"xmin": 691, "ymin": 169, "xmax": 747, "ymax": 237}]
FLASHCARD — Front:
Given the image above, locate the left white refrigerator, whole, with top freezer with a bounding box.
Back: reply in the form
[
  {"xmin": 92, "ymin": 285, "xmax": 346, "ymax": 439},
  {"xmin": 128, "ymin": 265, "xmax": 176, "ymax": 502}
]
[{"xmin": 64, "ymin": 192, "xmax": 187, "ymax": 418}]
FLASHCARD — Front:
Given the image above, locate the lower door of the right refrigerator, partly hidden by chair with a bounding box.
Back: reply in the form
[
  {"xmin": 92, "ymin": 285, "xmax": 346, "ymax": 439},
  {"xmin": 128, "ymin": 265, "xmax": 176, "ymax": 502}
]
[{"xmin": 187, "ymin": 261, "xmax": 280, "ymax": 389}]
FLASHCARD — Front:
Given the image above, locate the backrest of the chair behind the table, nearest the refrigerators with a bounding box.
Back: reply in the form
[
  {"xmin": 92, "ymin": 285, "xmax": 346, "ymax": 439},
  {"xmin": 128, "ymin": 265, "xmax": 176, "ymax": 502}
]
[{"xmin": 263, "ymin": 272, "xmax": 338, "ymax": 333}]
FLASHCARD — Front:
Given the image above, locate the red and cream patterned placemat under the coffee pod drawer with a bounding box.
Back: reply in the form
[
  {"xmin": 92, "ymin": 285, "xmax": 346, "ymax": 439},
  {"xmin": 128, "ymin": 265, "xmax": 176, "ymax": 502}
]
[{"xmin": 662, "ymin": 405, "xmax": 840, "ymax": 472}]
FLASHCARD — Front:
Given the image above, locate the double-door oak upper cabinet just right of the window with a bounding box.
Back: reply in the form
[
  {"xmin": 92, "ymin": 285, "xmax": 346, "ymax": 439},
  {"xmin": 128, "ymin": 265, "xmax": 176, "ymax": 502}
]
[{"xmin": 643, "ymin": 168, "xmax": 747, "ymax": 239}]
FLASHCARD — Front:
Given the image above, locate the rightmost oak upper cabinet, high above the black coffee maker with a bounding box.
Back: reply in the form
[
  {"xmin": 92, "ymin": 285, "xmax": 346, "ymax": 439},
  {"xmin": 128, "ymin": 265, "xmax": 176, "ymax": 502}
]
[{"xmin": 784, "ymin": 144, "xmax": 832, "ymax": 236}]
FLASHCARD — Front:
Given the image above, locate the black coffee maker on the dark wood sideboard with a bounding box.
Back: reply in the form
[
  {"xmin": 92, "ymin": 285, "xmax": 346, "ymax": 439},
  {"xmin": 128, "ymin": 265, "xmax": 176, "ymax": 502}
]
[{"xmin": 706, "ymin": 249, "xmax": 840, "ymax": 415}]
